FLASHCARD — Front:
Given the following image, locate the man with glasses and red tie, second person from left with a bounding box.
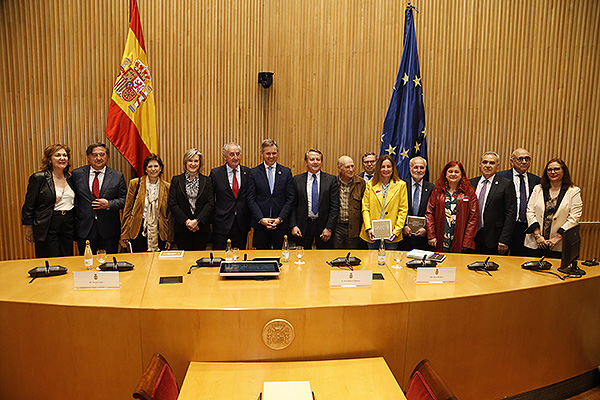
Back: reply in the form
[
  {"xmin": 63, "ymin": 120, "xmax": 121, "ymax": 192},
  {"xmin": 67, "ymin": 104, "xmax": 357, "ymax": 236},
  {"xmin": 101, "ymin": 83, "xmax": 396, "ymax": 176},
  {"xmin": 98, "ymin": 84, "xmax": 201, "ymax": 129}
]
[{"xmin": 72, "ymin": 142, "xmax": 127, "ymax": 255}]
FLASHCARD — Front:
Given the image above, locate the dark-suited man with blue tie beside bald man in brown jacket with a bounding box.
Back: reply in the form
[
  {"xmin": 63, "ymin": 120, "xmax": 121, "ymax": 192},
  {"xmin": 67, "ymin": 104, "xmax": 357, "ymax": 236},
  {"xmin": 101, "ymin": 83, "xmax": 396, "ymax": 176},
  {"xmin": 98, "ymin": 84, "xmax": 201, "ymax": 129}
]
[{"xmin": 290, "ymin": 149, "xmax": 340, "ymax": 249}]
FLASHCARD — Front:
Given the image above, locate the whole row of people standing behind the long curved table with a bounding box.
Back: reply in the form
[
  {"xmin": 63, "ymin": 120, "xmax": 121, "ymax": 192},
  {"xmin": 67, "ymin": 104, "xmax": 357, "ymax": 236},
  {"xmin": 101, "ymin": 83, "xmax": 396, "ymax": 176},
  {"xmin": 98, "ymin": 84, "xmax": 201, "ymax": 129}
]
[{"xmin": 22, "ymin": 139, "xmax": 582, "ymax": 258}]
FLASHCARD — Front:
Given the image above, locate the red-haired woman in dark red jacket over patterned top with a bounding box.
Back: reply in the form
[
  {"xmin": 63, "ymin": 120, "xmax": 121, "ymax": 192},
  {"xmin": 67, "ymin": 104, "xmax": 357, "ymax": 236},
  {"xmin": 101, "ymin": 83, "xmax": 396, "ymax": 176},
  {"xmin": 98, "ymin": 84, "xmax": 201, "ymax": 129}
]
[{"xmin": 425, "ymin": 161, "xmax": 479, "ymax": 253}]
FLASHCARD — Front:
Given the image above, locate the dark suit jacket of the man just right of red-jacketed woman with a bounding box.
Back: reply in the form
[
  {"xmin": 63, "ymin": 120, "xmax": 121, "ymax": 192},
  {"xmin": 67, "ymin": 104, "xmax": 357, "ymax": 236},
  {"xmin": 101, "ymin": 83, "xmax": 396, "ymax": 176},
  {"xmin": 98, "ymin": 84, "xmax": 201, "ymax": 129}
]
[{"xmin": 470, "ymin": 174, "xmax": 517, "ymax": 248}]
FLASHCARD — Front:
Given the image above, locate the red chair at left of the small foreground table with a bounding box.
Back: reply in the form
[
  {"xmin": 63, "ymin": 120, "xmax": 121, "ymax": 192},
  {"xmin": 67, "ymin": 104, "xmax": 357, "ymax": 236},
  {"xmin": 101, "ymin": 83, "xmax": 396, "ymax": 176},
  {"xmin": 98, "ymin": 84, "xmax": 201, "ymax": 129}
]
[{"xmin": 133, "ymin": 353, "xmax": 179, "ymax": 400}]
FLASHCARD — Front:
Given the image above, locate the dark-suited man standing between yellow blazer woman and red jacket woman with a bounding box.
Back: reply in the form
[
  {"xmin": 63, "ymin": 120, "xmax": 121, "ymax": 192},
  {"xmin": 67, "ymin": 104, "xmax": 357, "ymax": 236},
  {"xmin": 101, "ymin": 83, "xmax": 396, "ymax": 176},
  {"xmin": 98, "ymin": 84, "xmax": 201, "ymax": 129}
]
[{"xmin": 400, "ymin": 156, "xmax": 435, "ymax": 250}]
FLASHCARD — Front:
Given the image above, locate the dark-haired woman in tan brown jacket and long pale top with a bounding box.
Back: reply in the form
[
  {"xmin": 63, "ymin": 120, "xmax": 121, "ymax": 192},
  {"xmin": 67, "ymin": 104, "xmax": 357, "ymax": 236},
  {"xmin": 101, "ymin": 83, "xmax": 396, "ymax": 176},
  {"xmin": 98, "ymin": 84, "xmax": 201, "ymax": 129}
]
[{"xmin": 121, "ymin": 154, "xmax": 173, "ymax": 252}]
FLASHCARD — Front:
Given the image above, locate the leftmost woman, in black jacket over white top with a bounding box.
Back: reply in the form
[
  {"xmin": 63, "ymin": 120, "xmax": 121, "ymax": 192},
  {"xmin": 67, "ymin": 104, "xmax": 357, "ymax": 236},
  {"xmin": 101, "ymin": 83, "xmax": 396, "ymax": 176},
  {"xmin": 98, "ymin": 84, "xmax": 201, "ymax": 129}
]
[{"xmin": 21, "ymin": 144, "xmax": 75, "ymax": 258}]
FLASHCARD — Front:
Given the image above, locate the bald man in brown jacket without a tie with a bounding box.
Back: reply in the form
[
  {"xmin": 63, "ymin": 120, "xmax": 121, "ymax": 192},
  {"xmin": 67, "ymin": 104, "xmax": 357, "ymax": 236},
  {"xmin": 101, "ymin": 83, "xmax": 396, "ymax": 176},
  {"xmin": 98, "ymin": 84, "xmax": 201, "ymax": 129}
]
[{"xmin": 333, "ymin": 156, "xmax": 366, "ymax": 249}]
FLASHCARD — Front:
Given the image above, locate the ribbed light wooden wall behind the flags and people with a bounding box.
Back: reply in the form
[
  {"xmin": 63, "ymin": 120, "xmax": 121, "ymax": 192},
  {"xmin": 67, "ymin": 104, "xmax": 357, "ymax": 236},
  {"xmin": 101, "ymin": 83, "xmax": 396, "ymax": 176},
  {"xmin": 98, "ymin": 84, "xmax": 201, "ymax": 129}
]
[{"xmin": 0, "ymin": 0, "xmax": 600, "ymax": 259}]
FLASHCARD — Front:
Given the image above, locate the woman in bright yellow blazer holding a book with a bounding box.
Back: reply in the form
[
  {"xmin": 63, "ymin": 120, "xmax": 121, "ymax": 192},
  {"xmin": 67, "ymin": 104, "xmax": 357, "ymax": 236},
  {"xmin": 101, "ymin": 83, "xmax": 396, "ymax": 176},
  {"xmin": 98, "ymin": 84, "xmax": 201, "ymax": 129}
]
[{"xmin": 360, "ymin": 154, "xmax": 408, "ymax": 250}]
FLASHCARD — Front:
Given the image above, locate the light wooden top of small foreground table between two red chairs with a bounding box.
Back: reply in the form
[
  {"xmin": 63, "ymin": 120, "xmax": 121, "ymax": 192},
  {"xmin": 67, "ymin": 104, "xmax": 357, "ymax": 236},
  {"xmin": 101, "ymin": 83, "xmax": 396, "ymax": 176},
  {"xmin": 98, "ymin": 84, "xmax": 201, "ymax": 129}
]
[{"xmin": 178, "ymin": 357, "xmax": 406, "ymax": 400}]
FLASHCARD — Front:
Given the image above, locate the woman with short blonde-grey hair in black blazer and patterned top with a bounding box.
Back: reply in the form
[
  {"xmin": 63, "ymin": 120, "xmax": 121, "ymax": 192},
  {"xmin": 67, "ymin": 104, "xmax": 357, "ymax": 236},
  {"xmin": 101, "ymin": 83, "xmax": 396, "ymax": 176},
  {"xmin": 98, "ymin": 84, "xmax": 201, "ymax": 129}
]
[{"xmin": 169, "ymin": 149, "xmax": 215, "ymax": 250}]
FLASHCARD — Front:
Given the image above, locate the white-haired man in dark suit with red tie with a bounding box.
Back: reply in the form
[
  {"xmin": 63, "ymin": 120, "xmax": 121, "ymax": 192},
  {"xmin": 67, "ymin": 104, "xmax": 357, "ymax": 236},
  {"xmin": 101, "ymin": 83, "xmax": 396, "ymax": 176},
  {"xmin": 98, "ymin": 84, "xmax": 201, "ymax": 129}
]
[{"xmin": 210, "ymin": 142, "xmax": 250, "ymax": 250}]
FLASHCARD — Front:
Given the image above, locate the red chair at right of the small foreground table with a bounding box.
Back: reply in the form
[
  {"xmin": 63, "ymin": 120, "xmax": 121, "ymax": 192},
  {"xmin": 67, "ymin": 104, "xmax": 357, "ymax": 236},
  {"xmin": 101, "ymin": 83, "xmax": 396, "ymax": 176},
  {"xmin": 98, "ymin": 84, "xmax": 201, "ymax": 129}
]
[{"xmin": 406, "ymin": 359, "xmax": 457, "ymax": 400}]
